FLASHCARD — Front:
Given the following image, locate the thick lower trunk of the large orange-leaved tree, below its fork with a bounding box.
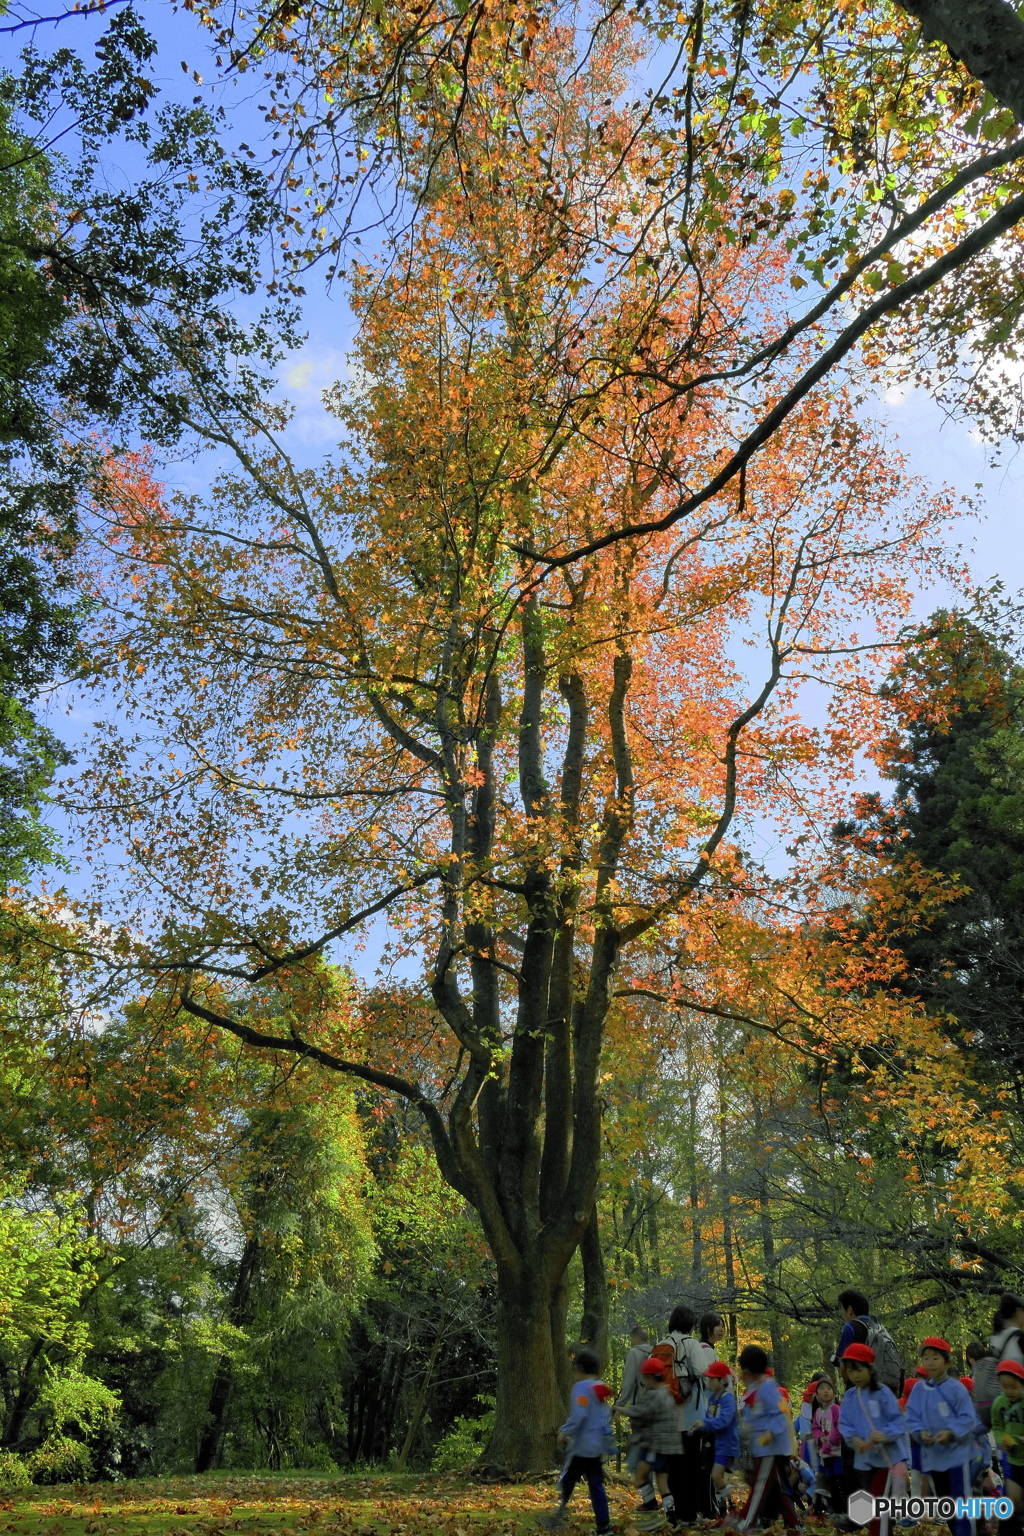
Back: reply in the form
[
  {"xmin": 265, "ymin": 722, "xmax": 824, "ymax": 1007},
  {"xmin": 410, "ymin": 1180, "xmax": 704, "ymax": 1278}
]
[{"xmin": 482, "ymin": 1276, "xmax": 567, "ymax": 1473}]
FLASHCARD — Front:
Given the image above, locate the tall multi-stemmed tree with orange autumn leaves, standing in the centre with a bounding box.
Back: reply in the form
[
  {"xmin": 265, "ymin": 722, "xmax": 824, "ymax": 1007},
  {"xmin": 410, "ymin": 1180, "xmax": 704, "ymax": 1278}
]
[{"xmin": 67, "ymin": 12, "xmax": 982, "ymax": 1470}]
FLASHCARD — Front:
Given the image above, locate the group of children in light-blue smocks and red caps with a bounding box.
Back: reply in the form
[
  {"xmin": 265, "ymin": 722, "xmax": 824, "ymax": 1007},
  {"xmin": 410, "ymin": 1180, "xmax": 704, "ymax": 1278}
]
[{"xmin": 542, "ymin": 1336, "xmax": 1024, "ymax": 1536}]
